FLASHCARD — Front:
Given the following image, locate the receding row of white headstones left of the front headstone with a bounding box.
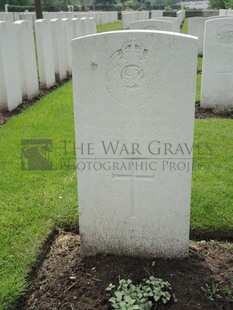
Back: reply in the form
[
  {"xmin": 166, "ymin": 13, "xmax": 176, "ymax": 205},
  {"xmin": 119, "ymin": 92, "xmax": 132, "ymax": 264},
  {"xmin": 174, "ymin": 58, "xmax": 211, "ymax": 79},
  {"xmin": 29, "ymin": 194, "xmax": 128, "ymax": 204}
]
[{"xmin": 0, "ymin": 18, "xmax": 96, "ymax": 111}]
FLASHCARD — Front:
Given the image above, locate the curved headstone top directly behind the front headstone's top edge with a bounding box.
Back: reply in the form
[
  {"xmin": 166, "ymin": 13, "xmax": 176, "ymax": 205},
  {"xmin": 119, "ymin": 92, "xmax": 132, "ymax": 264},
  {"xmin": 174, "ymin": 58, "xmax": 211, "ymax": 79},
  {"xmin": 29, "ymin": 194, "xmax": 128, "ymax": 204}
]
[{"xmin": 129, "ymin": 19, "xmax": 172, "ymax": 31}]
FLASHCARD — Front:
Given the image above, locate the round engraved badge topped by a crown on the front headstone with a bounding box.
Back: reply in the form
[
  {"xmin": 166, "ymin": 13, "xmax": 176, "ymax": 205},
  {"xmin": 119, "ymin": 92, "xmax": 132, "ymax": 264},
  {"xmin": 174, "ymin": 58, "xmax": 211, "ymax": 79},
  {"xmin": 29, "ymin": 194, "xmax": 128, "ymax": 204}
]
[{"xmin": 107, "ymin": 39, "xmax": 161, "ymax": 107}]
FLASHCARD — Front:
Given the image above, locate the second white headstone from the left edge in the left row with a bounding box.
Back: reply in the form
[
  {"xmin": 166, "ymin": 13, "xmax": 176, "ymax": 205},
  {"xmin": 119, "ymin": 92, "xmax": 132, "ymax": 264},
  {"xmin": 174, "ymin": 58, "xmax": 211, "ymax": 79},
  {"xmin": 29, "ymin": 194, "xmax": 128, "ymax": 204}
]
[{"xmin": 14, "ymin": 20, "xmax": 39, "ymax": 99}]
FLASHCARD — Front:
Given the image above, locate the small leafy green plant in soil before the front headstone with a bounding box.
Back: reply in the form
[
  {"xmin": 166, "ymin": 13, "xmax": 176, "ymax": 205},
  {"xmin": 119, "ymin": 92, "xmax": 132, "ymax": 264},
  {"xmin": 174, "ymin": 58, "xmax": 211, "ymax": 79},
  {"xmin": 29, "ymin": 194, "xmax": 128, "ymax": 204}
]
[{"xmin": 106, "ymin": 276, "xmax": 171, "ymax": 310}]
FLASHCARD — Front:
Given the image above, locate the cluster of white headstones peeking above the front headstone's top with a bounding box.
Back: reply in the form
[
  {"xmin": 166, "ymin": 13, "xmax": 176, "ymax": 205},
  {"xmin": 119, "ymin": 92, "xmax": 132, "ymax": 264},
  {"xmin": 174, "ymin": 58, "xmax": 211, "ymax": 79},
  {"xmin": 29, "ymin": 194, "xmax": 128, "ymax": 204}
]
[{"xmin": 122, "ymin": 10, "xmax": 185, "ymax": 32}]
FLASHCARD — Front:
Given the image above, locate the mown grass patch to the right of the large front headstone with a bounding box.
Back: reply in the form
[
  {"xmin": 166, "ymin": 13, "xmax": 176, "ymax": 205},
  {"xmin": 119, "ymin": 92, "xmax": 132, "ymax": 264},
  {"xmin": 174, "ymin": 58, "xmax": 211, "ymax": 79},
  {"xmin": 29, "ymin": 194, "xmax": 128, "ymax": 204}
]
[{"xmin": 191, "ymin": 119, "xmax": 233, "ymax": 230}]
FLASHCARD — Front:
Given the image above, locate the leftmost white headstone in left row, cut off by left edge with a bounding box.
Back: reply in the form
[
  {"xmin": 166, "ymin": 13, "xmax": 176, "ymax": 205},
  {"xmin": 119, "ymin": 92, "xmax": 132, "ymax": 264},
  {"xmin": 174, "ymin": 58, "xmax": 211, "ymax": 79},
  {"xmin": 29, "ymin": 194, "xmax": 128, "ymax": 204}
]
[{"xmin": 0, "ymin": 21, "xmax": 22, "ymax": 111}]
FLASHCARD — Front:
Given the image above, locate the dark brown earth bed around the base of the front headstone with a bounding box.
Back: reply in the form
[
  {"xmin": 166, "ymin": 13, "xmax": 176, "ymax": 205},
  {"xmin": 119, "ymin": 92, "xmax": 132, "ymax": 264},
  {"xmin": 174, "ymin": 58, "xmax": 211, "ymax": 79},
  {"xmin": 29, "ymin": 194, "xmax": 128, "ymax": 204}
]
[{"xmin": 17, "ymin": 232, "xmax": 233, "ymax": 310}]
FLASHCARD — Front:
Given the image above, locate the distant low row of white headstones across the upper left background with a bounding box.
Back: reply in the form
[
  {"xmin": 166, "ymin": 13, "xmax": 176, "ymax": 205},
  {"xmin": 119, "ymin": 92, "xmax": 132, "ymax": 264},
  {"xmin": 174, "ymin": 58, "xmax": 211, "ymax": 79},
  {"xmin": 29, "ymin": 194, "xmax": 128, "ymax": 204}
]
[{"xmin": 0, "ymin": 11, "xmax": 118, "ymax": 25}]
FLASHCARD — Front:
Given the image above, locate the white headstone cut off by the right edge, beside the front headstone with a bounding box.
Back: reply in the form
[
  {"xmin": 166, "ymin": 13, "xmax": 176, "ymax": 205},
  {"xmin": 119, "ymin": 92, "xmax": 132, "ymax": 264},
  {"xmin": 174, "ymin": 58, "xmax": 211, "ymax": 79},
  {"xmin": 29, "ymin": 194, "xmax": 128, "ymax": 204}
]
[{"xmin": 201, "ymin": 18, "xmax": 233, "ymax": 110}]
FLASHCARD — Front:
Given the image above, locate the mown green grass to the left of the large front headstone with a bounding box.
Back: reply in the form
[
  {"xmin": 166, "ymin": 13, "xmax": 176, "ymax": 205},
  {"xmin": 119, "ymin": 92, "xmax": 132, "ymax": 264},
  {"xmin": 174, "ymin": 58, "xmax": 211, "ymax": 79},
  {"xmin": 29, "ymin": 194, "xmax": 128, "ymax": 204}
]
[{"xmin": 0, "ymin": 82, "xmax": 78, "ymax": 310}]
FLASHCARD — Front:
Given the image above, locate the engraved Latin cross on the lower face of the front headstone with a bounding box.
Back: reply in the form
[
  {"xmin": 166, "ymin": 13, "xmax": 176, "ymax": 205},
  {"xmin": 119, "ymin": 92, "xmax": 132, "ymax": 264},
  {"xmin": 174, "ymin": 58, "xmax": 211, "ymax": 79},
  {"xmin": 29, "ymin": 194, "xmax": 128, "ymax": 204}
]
[{"xmin": 112, "ymin": 169, "xmax": 155, "ymax": 217}]
